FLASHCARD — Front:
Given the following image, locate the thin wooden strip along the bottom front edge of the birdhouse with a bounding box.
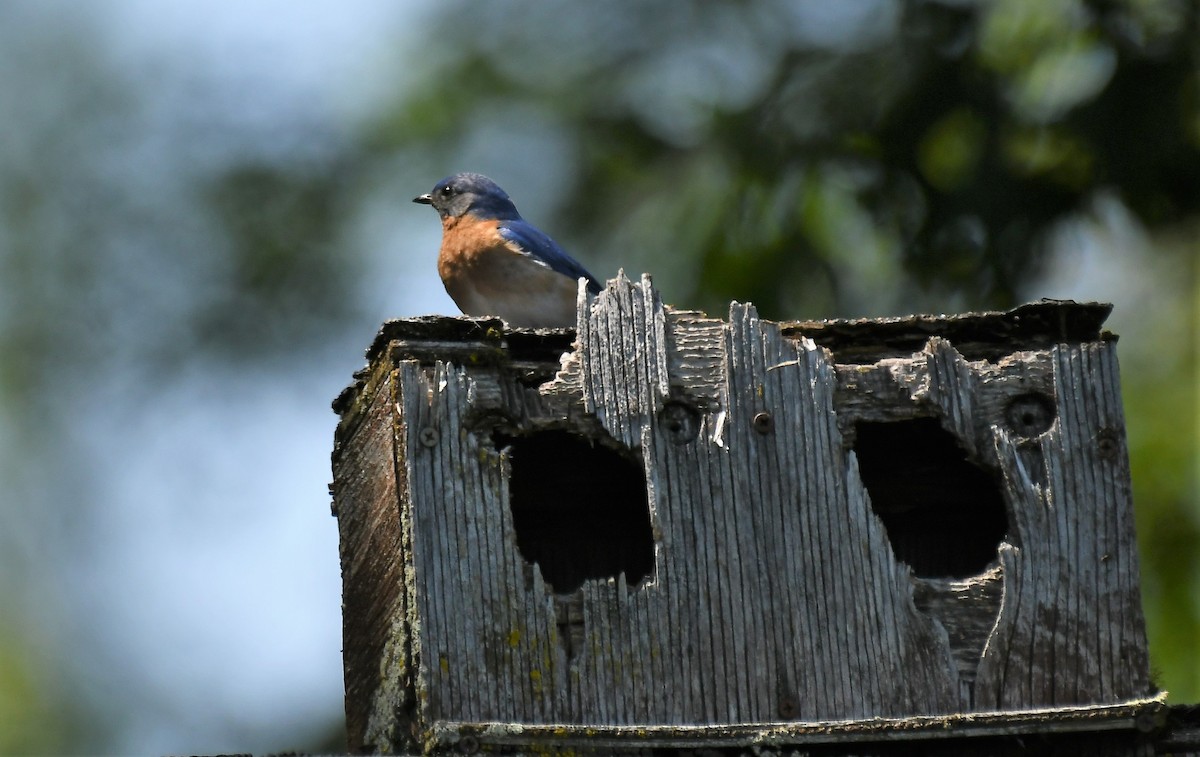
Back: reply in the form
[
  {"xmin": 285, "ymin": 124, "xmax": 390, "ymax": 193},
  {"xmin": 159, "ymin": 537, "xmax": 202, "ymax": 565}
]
[{"xmin": 426, "ymin": 692, "xmax": 1170, "ymax": 751}]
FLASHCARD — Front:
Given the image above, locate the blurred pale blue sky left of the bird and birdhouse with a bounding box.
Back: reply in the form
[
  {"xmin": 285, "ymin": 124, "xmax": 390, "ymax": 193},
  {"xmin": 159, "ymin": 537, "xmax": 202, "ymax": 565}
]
[{"xmin": 0, "ymin": 0, "xmax": 441, "ymax": 755}]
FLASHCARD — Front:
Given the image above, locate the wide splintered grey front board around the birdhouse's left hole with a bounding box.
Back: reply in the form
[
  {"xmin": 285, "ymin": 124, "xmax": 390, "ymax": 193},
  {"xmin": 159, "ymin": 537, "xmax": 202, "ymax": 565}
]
[{"xmin": 398, "ymin": 273, "xmax": 958, "ymax": 725}]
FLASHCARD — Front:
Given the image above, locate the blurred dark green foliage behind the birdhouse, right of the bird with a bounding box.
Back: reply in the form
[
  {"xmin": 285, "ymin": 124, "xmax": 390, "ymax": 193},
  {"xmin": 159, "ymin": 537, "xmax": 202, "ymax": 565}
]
[{"xmin": 367, "ymin": 0, "xmax": 1200, "ymax": 699}]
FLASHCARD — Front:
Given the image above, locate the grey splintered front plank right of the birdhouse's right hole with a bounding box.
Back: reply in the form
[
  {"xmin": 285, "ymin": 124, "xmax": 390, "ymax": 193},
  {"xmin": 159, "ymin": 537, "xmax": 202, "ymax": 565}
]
[{"xmin": 977, "ymin": 342, "xmax": 1152, "ymax": 709}]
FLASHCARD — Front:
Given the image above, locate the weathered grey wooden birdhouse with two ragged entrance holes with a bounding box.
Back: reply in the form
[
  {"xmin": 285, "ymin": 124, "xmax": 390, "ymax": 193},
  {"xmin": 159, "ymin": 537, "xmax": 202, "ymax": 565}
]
[{"xmin": 334, "ymin": 276, "xmax": 1162, "ymax": 755}]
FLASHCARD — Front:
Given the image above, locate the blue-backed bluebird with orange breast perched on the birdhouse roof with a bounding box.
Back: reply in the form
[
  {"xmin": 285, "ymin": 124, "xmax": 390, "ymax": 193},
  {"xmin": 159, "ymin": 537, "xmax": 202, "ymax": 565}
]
[{"xmin": 413, "ymin": 174, "xmax": 600, "ymax": 329}]
